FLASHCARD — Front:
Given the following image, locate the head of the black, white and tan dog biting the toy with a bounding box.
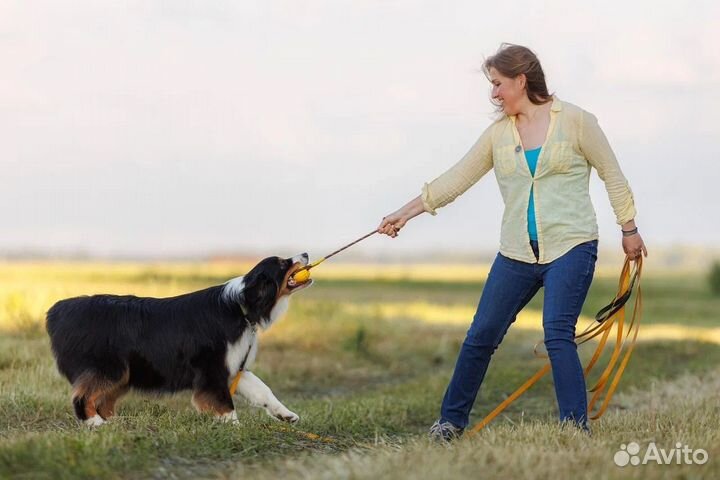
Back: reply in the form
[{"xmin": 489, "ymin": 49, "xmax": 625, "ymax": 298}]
[{"xmin": 242, "ymin": 253, "xmax": 313, "ymax": 325}]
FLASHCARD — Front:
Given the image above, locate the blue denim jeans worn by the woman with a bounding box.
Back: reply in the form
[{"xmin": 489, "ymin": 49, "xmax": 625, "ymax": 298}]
[{"xmin": 440, "ymin": 240, "xmax": 597, "ymax": 429}]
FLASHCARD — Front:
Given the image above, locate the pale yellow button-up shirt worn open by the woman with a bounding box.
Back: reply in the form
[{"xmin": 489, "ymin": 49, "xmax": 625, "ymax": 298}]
[{"xmin": 422, "ymin": 97, "xmax": 635, "ymax": 263}]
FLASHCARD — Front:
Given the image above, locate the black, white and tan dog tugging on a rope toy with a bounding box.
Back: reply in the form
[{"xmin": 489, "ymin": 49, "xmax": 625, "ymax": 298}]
[{"xmin": 47, "ymin": 253, "xmax": 312, "ymax": 426}]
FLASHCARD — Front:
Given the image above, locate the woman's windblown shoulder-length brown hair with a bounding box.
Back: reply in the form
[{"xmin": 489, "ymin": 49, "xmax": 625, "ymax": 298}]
[{"xmin": 483, "ymin": 43, "xmax": 552, "ymax": 109}]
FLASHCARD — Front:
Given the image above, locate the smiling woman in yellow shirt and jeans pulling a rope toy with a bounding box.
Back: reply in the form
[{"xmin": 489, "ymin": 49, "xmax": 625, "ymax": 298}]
[{"xmin": 378, "ymin": 44, "xmax": 647, "ymax": 440}]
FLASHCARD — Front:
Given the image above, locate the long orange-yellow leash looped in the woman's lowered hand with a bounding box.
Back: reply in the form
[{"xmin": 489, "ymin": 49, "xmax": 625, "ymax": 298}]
[{"xmin": 465, "ymin": 256, "xmax": 642, "ymax": 437}]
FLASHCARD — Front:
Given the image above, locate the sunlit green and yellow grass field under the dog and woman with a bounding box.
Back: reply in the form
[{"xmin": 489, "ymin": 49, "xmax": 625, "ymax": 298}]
[{"xmin": 0, "ymin": 263, "xmax": 720, "ymax": 480}]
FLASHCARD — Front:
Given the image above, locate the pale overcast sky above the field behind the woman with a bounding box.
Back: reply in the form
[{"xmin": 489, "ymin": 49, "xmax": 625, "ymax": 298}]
[{"xmin": 0, "ymin": 0, "xmax": 720, "ymax": 256}]
